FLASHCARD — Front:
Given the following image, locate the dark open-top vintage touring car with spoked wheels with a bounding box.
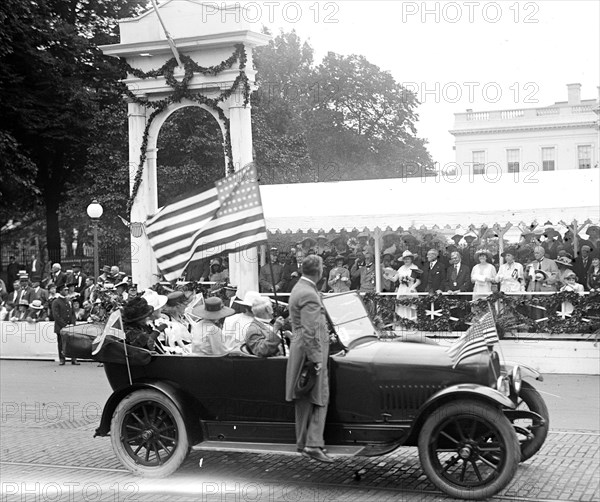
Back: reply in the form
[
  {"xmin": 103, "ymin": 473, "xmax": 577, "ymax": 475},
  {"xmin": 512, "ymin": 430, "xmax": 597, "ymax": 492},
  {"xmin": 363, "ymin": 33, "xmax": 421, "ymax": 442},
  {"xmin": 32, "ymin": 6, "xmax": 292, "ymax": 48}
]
[{"xmin": 64, "ymin": 292, "xmax": 549, "ymax": 499}]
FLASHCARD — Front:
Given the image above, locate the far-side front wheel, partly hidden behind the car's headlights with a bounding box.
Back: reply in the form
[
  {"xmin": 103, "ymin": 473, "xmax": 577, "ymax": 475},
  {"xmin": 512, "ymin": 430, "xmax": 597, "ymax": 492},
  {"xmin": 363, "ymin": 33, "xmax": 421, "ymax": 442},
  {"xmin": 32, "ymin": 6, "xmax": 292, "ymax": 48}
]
[{"xmin": 512, "ymin": 382, "xmax": 550, "ymax": 462}]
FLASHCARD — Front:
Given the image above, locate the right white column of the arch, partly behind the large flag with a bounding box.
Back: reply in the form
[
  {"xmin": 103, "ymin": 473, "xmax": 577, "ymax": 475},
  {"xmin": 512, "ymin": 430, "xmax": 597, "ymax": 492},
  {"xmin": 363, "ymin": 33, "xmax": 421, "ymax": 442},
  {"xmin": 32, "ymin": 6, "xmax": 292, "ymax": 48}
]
[{"xmin": 227, "ymin": 96, "xmax": 258, "ymax": 298}]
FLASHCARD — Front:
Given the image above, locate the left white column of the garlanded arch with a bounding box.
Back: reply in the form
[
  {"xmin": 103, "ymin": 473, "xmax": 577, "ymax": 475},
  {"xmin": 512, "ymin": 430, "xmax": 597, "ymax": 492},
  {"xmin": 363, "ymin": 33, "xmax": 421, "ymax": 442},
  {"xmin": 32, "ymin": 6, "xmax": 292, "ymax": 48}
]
[{"xmin": 127, "ymin": 102, "xmax": 158, "ymax": 290}]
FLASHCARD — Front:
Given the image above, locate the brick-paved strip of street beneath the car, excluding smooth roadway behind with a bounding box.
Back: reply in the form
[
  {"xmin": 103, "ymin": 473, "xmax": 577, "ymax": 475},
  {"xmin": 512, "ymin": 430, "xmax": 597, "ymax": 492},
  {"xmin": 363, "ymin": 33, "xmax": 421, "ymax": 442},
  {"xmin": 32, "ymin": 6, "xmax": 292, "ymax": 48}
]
[{"xmin": 0, "ymin": 404, "xmax": 600, "ymax": 502}]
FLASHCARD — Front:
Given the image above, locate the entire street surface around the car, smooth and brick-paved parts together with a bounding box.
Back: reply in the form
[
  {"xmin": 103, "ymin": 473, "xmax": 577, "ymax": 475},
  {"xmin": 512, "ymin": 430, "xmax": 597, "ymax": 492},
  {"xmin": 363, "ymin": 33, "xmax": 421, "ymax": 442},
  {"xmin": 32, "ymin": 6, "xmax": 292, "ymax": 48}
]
[{"xmin": 0, "ymin": 360, "xmax": 600, "ymax": 502}]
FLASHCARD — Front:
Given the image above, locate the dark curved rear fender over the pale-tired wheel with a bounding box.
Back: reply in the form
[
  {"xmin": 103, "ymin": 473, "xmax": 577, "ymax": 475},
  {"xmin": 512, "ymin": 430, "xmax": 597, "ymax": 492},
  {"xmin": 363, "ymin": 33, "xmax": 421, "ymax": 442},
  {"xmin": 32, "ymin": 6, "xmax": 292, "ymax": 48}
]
[{"xmin": 94, "ymin": 380, "xmax": 202, "ymax": 444}]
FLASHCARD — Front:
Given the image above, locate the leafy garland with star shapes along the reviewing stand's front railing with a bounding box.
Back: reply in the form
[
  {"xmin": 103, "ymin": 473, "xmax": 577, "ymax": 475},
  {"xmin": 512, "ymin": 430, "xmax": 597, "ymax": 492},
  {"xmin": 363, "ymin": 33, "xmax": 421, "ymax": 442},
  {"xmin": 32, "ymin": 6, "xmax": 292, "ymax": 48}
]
[{"xmin": 364, "ymin": 291, "xmax": 600, "ymax": 337}]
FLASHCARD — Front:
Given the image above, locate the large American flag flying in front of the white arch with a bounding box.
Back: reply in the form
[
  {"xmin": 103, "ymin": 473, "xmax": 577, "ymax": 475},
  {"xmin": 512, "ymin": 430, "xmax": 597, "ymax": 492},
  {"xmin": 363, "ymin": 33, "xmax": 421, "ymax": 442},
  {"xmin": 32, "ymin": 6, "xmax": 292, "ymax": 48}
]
[{"xmin": 146, "ymin": 164, "xmax": 267, "ymax": 281}]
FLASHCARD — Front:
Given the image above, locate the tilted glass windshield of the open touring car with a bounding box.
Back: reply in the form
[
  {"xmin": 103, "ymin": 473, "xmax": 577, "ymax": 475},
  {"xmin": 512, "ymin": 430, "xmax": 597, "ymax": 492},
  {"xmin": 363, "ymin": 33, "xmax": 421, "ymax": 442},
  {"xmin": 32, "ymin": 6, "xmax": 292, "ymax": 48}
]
[{"xmin": 323, "ymin": 291, "xmax": 377, "ymax": 347}]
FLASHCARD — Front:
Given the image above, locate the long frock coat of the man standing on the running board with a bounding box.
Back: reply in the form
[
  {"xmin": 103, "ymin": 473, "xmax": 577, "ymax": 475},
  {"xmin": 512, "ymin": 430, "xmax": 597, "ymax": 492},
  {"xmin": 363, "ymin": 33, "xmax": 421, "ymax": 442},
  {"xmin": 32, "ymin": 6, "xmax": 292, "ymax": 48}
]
[{"xmin": 285, "ymin": 279, "xmax": 329, "ymax": 406}]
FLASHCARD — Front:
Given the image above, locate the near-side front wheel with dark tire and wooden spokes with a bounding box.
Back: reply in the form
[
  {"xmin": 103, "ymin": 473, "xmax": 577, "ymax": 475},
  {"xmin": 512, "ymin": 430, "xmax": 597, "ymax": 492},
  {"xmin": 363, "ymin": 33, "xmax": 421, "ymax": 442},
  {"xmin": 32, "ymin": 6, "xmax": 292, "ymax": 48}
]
[{"xmin": 419, "ymin": 399, "xmax": 521, "ymax": 500}]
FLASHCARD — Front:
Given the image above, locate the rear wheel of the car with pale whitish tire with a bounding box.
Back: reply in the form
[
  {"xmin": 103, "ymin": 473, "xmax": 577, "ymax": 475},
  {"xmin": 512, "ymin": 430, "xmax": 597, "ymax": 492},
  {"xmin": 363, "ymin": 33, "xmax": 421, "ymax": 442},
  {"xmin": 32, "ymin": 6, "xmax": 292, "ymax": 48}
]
[{"xmin": 110, "ymin": 389, "xmax": 190, "ymax": 478}]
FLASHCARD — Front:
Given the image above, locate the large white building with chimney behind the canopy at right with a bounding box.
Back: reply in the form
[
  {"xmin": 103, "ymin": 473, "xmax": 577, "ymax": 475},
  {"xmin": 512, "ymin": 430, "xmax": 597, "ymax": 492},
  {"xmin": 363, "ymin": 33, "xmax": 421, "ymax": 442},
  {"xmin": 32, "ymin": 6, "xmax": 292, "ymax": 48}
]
[{"xmin": 450, "ymin": 84, "xmax": 600, "ymax": 180}]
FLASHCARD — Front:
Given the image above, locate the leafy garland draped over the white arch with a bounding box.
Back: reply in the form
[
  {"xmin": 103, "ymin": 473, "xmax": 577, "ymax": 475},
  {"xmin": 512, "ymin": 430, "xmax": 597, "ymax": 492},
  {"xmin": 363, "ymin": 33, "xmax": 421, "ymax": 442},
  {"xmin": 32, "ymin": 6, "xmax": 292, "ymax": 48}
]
[{"xmin": 119, "ymin": 44, "xmax": 250, "ymax": 214}]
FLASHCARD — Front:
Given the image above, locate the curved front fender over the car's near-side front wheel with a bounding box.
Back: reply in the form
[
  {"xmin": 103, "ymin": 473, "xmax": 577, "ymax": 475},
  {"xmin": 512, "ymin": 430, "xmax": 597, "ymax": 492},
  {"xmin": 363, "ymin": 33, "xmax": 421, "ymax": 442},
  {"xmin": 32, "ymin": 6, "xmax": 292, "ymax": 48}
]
[{"xmin": 404, "ymin": 383, "xmax": 516, "ymax": 446}]
